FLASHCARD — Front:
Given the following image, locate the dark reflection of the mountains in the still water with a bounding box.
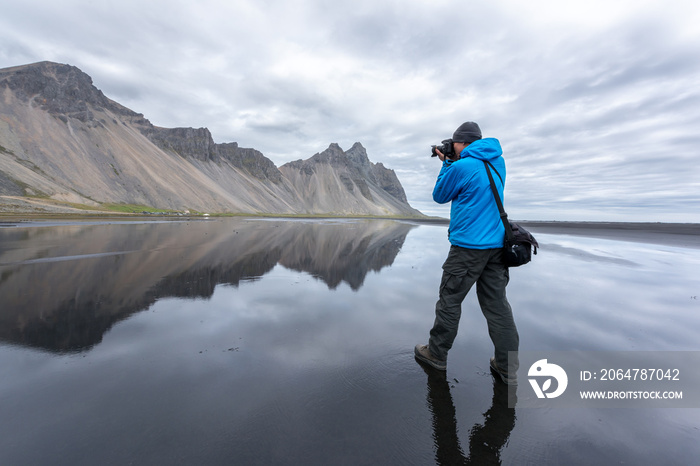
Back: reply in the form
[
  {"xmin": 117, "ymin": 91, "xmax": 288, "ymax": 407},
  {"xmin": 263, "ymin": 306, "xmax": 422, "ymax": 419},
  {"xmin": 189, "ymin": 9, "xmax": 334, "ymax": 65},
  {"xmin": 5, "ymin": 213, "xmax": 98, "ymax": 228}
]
[{"xmin": 0, "ymin": 219, "xmax": 413, "ymax": 352}]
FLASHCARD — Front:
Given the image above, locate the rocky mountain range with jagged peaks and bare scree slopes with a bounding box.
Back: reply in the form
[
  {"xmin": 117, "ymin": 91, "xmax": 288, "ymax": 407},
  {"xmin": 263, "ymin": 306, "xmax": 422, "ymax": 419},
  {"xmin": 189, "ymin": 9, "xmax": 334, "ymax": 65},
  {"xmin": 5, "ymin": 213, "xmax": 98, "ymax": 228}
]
[{"xmin": 0, "ymin": 62, "xmax": 422, "ymax": 216}]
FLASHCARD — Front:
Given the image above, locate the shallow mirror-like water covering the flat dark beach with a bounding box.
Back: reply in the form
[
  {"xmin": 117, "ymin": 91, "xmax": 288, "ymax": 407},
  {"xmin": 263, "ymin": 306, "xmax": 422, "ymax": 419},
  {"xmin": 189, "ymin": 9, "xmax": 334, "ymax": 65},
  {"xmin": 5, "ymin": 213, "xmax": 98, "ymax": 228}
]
[{"xmin": 0, "ymin": 219, "xmax": 700, "ymax": 465}]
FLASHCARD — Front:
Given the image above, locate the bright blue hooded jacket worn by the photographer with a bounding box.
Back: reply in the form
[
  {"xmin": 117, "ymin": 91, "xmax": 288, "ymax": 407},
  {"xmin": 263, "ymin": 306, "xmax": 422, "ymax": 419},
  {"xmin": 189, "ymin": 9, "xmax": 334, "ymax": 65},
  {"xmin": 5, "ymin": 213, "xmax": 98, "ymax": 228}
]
[{"xmin": 433, "ymin": 138, "xmax": 506, "ymax": 249}]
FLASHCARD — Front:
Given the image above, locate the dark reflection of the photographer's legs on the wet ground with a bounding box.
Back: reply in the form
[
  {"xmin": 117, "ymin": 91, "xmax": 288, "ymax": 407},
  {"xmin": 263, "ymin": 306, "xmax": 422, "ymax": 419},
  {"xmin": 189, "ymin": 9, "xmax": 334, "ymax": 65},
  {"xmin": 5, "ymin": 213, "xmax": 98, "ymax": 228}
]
[{"xmin": 421, "ymin": 364, "xmax": 516, "ymax": 465}]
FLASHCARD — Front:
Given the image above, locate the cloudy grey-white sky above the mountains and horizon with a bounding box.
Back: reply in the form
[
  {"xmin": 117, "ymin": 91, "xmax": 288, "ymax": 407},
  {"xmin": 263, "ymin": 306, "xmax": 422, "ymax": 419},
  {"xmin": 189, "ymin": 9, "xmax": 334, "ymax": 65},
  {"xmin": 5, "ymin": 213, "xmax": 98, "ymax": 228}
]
[{"xmin": 0, "ymin": 0, "xmax": 700, "ymax": 222}]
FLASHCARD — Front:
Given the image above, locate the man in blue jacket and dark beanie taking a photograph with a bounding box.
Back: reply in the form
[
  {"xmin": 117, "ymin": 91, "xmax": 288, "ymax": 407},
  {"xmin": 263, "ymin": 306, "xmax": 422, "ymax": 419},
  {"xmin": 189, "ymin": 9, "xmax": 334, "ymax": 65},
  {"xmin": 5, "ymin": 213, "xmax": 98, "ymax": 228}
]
[{"xmin": 415, "ymin": 121, "xmax": 519, "ymax": 384}]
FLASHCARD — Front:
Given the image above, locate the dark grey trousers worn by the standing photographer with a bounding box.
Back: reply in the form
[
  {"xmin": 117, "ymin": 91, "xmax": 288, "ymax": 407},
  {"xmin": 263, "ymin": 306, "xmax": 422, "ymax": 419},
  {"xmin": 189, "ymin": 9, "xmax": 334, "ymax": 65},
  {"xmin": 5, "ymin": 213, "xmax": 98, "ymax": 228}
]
[{"xmin": 429, "ymin": 246, "xmax": 520, "ymax": 374}]
